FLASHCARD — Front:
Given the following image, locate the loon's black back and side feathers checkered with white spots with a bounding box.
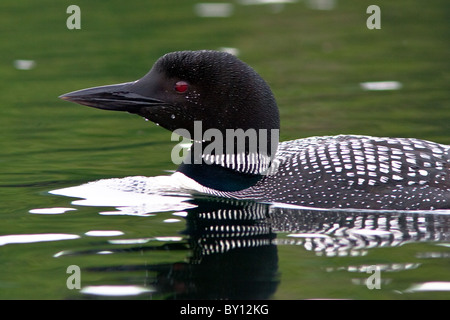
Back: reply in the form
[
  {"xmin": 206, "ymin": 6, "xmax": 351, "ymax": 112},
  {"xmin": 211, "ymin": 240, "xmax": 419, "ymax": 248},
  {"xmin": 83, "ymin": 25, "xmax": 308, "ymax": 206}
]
[{"xmin": 215, "ymin": 135, "xmax": 450, "ymax": 210}]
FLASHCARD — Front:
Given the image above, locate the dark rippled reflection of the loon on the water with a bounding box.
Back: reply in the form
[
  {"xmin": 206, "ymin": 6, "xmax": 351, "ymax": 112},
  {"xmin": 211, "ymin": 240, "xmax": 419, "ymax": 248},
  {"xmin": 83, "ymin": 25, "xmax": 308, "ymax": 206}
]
[{"xmin": 58, "ymin": 198, "xmax": 450, "ymax": 299}]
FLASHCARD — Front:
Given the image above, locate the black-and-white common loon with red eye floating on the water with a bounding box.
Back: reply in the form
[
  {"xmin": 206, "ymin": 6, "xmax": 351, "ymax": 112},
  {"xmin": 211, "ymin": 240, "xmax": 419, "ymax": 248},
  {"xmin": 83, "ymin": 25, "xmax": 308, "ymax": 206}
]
[{"xmin": 60, "ymin": 50, "xmax": 450, "ymax": 210}]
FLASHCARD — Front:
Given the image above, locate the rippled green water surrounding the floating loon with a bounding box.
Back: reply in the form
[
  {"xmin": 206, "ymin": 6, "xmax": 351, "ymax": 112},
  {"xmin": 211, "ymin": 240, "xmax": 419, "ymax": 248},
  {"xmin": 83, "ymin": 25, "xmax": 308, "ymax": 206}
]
[{"xmin": 0, "ymin": 0, "xmax": 450, "ymax": 299}]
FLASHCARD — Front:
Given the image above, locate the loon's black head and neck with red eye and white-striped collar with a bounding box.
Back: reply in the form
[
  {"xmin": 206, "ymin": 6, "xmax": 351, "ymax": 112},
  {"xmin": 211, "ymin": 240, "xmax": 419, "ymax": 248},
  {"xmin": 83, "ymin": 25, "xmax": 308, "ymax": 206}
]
[{"xmin": 60, "ymin": 50, "xmax": 280, "ymax": 191}]
